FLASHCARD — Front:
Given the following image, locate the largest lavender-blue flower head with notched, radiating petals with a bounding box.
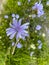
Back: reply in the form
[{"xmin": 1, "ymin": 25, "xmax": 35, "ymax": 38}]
[{"xmin": 6, "ymin": 19, "xmax": 29, "ymax": 40}]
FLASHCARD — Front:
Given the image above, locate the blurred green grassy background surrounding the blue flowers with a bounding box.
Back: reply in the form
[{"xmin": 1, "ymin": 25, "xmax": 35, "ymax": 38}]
[{"xmin": 0, "ymin": 0, "xmax": 49, "ymax": 65}]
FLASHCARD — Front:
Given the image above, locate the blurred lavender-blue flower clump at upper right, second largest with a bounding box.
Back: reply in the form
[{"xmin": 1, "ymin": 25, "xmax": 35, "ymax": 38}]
[{"xmin": 32, "ymin": 2, "xmax": 44, "ymax": 17}]
